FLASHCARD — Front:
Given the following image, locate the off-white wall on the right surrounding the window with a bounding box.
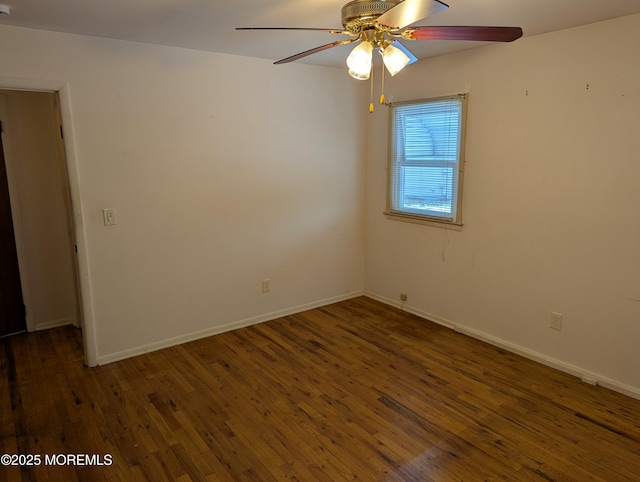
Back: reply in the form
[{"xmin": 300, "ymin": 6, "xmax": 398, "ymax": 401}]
[{"xmin": 365, "ymin": 15, "xmax": 640, "ymax": 395}]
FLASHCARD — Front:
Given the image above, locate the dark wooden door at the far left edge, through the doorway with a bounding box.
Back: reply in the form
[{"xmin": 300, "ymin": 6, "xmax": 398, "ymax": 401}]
[{"xmin": 0, "ymin": 123, "xmax": 27, "ymax": 336}]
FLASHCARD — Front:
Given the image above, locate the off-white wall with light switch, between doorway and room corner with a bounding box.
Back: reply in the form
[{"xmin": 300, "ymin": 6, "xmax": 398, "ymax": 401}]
[{"xmin": 0, "ymin": 23, "xmax": 364, "ymax": 362}]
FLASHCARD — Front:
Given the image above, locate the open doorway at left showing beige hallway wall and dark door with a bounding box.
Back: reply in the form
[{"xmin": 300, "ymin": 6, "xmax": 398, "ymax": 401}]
[{"xmin": 0, "ymin": 90, "xmax": 81, "ymax": 336}]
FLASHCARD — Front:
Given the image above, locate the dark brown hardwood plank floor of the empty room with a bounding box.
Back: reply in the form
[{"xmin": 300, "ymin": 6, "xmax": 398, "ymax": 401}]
[{"xmin": 0, "ymin": 297, "xmax": 640, "ymax": 482}]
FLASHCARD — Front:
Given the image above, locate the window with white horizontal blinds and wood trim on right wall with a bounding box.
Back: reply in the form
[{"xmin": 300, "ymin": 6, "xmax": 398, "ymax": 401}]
[{"xmin": 386, "ymin": 94, "xmax": 467, "ymax": 230}]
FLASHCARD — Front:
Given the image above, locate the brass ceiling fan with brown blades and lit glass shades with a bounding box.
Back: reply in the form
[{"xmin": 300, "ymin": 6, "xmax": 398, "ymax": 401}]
[{"xmin": 236, "ymin": 0, "xmax": 522, "ymax": 111}]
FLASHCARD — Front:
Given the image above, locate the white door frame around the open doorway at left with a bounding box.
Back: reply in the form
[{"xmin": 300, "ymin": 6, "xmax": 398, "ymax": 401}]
[{"xmin": 0, "ymin": 77, "xmax": 98, "ymax": 367}]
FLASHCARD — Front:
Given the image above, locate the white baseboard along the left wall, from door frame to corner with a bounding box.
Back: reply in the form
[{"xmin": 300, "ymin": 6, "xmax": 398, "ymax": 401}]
[{"xmin": 97, "ymin": 291, "xmax": 364, "ymax": 365}]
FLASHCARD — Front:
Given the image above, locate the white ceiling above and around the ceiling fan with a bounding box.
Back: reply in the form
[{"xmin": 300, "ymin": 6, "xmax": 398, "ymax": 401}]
[{"xmin": 0, "ymin": 0, "xmax": 640, "ymax": 66}]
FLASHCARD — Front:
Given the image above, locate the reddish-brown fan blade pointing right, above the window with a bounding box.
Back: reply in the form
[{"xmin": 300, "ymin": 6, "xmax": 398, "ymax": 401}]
[{"xmin": 402, "ymin": 27, "xmax": 522, "ymax": 42}]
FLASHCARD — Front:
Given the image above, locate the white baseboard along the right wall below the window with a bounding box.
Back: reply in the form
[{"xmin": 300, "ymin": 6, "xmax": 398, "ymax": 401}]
[{"xmin": 364, "ymin": 291, "xmax": 640, "ymax": 400}]
